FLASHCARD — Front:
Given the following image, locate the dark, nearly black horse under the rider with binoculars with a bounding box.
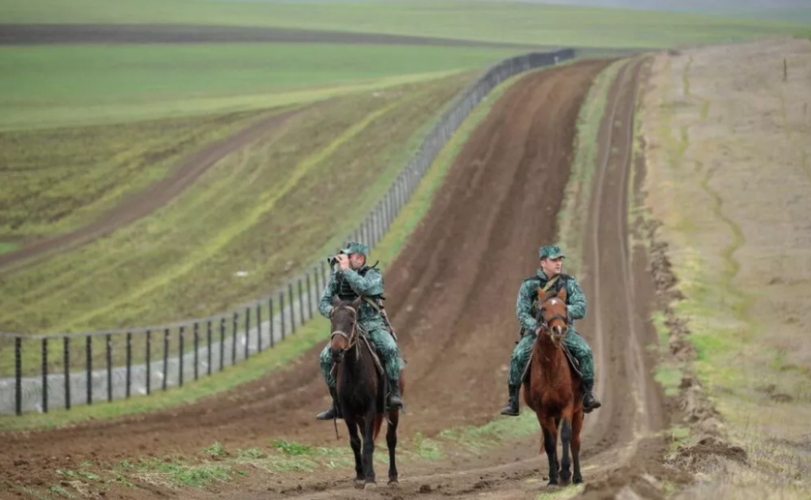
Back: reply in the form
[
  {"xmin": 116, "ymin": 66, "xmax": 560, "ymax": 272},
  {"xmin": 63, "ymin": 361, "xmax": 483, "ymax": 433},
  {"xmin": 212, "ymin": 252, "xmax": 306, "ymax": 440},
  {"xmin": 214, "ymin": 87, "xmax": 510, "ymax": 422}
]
[{"xmin": 330, "ymin": 297, "xmax": 403, "ymax": 488}]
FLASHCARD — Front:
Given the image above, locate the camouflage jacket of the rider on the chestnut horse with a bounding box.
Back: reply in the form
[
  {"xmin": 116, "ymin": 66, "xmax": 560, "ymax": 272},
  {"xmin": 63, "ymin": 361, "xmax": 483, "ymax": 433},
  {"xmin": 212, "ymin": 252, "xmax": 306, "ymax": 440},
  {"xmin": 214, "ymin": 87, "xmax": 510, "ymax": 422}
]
[{"xmin": 515, "ymin": 269, "xmax": 586, "ymax": 332}]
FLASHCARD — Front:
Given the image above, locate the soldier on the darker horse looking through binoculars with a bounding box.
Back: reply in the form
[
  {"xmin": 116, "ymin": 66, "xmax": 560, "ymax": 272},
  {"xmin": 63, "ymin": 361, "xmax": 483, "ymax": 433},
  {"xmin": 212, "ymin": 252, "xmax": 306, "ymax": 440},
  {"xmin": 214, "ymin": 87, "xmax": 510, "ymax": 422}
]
[{"xmin": 316, "ymin": 242, "xmax": 403, "ymax": 420}]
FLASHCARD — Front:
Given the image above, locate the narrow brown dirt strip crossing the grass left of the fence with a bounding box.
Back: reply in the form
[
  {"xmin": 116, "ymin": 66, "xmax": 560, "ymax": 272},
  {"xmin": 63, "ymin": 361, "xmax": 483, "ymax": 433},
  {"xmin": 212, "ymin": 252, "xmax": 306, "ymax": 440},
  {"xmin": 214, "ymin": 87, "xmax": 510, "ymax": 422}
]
[{"xmin": 0, "ymin": 110, "xmax": 301, "ymax": 276}]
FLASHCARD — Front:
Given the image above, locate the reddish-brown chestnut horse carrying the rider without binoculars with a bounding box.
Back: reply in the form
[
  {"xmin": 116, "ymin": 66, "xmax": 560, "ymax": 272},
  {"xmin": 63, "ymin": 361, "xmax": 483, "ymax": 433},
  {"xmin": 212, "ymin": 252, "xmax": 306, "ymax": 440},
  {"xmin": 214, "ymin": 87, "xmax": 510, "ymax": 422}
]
[{"xmin": 524, "ymin": 289, "xmax": 584, "ymax": 485}]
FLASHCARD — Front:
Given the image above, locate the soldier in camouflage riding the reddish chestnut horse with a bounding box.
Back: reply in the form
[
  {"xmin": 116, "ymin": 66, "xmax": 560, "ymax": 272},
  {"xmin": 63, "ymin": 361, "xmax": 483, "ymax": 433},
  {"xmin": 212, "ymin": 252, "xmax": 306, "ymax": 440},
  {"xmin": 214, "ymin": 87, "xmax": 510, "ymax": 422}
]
[{"xmin": 501, "ymin": 245, "xmax": 602, "ymax": 417}]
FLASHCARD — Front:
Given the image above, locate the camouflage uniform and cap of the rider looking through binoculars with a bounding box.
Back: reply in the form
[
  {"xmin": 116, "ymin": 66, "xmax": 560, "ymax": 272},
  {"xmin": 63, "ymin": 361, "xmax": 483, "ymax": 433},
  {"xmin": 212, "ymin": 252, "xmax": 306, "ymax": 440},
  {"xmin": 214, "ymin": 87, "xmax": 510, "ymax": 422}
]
[{"xmin": 318, "ymin": 243, "xmax": 402, "ymax": 420}]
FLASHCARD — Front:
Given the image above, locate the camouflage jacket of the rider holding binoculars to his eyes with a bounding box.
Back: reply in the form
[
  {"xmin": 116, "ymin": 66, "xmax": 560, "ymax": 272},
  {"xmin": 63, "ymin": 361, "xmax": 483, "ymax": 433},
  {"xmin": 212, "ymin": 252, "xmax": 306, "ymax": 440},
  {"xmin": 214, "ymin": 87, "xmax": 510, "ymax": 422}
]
[{"xmin": 318, "ymin": 266, "xmax": 385, "ymax": 332}]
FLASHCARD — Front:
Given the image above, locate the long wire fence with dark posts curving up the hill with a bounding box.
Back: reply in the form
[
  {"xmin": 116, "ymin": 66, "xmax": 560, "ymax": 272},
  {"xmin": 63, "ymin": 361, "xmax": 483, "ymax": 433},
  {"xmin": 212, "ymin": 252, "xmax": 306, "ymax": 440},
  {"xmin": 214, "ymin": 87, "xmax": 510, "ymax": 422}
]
[{"xmin": 0, "ymin": 49, "xmax": 575, "ymax": 415}]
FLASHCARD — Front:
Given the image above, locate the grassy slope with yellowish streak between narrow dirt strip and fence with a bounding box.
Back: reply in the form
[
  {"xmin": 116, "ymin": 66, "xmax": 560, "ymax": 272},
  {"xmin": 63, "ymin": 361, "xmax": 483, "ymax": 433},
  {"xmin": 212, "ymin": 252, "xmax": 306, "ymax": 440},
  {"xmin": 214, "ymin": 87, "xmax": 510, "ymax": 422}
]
[{"xmin": 0, "ymin": 74, "xmax": 471, "ymax": 331}]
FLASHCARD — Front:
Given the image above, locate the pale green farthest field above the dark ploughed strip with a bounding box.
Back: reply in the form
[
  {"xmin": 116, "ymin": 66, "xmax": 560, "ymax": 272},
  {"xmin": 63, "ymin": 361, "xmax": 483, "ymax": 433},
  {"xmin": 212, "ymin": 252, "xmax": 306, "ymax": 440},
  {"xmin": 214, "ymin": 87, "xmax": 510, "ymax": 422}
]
[{"xmin": 0, "ymin": 0, "xmax": 798, "ymax": 47}]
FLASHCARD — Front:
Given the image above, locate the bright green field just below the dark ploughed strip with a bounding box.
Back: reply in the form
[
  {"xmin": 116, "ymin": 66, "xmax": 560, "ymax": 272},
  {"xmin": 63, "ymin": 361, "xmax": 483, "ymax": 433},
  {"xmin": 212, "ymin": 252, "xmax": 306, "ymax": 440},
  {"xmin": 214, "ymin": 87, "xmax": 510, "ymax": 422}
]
[{"xmin": 0, "ymin": 43, "xmax": 515, "ymax": 130}]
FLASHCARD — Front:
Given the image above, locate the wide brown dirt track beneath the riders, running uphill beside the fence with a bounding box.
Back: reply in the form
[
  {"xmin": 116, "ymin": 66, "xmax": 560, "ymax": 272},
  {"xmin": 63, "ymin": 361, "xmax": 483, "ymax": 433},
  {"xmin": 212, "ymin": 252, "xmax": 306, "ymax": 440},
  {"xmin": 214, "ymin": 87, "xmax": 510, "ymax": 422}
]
[{"xmin": 0, "ymin": 56, "xmax": 662, "ymax": 499}]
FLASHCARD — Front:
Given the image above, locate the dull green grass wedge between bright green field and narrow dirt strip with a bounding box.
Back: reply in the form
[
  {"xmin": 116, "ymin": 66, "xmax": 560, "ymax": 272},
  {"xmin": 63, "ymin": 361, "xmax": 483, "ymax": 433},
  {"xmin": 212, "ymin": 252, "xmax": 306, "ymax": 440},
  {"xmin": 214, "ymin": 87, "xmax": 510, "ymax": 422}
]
[{"xmin": 0, "ymin": 112, "xmax": 280, "ymax": 241}]
